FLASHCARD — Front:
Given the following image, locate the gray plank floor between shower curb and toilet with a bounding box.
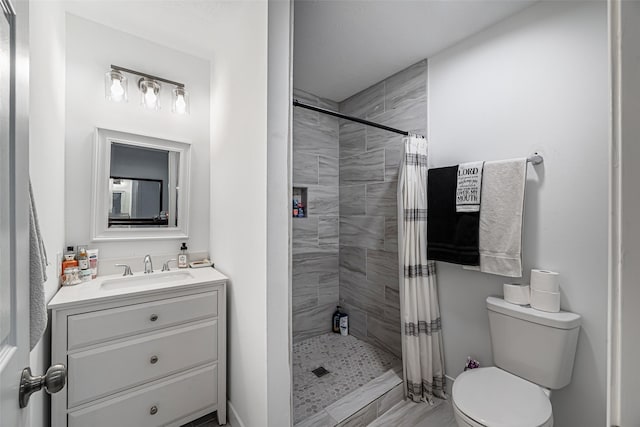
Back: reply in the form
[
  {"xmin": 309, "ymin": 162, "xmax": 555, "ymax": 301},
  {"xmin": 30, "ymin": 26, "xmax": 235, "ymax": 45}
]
[{"xmin": 369, "ymin": 399, "xmax": 458, "ymax": 427}]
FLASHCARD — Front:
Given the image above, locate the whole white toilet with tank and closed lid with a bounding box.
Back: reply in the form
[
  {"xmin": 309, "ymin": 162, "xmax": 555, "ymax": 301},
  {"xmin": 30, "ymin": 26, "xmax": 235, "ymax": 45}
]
[{"xmin": 452, "ymin": 297, "xmax": 581, "ymax": 427}]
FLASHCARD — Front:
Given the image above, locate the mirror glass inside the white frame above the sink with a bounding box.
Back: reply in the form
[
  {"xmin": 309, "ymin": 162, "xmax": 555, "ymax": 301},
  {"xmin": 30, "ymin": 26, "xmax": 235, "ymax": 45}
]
[{"xmin": 109, "ymin": 142, "xmax": 180, "ymax": 228}]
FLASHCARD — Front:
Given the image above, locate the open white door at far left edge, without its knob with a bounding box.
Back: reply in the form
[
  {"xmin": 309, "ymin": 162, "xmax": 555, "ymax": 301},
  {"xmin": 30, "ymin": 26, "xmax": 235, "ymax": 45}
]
[{"xmin": 0, "ymin": 0, "xmax": 29, "ymax": 427}]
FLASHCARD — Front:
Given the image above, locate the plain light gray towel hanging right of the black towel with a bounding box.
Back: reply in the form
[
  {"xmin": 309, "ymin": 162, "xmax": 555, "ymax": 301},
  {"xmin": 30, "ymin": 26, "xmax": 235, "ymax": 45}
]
[{"xmin": 465, "ymin": 158, "xmax": 527, "ymax": 277}]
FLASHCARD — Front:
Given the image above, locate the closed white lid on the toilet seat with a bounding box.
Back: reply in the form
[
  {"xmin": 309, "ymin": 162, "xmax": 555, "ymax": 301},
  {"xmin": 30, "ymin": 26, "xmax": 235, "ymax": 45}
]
[{"xmin": 453, "ymin": 367, "xmax": 551, "ymax": 427}]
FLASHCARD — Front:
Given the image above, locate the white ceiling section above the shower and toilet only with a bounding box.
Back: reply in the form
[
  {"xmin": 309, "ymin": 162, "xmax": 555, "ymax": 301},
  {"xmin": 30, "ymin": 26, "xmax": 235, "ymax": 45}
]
[{"xmin": 293, "ymin": 0, "xmax": 535, "ymax": 102}]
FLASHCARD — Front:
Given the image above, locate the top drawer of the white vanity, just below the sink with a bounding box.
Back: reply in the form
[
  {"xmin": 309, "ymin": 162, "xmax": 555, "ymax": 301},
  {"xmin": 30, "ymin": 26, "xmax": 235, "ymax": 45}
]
[{"xmin": 67, "ymin": 291, "xmax": 218, "ymax": 350}]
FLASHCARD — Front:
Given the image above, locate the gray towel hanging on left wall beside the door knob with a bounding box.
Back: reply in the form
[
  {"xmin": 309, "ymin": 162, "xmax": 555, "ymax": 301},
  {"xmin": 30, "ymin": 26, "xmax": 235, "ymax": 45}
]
[{"xmin": 29, "ymin": 182, "xmax": 48, "ymax": 350}]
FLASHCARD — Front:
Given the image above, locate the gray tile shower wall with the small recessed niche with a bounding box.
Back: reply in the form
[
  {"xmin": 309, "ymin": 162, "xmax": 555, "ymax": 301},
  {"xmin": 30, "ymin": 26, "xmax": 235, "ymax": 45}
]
[{"xmin": 292, "ymin": 90, "xmax": 338, "ymax": 342}]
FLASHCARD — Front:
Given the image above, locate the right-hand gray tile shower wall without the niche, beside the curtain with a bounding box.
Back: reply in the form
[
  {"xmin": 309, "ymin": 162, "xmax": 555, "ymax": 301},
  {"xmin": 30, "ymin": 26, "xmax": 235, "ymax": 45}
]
[{"xmin": 338, "ymin": 60, "xmax": 427, "ymax": 356}]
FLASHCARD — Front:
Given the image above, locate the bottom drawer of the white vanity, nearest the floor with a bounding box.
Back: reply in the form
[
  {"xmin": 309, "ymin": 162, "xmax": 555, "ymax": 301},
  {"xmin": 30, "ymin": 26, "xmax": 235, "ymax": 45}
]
[{"xmin": 68, "ymin": 365, "xmax": 218, "ymax": 427}]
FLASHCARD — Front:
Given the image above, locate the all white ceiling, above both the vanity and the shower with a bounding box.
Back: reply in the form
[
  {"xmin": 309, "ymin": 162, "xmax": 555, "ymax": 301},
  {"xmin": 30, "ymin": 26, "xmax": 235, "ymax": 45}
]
[{"xmin": 62, "ymin": 0, "xmax": 537, "ymax": 101}]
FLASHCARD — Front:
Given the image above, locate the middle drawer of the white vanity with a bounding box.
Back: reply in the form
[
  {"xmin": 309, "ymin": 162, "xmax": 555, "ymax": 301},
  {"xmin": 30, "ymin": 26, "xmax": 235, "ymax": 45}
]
[{"xmin": 67, "ymin": 320, "xmax": 218, "ymax": 408}]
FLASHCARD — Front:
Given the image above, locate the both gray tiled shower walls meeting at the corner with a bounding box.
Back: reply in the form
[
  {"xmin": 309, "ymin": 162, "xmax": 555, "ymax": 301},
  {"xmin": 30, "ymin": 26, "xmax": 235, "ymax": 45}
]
[{"xmin": 292, "ymin": 60, "xmax": 427, "ymax": 356}]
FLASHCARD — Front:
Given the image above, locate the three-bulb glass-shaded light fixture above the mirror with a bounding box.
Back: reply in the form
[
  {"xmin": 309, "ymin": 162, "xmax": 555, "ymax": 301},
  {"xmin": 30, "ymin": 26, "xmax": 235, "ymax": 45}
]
[{"xmin": 105, "ymin": 65, "xmax": 189, "ymax": 114}]
